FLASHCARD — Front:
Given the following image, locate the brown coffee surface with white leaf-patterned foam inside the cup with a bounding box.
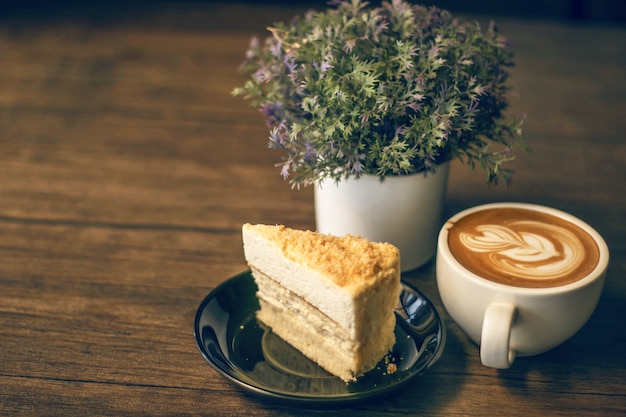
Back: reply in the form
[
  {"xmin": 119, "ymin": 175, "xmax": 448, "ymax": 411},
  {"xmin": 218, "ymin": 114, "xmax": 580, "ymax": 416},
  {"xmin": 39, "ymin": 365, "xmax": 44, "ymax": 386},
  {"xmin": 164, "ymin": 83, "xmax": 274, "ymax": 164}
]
[{"xmin": 448, "ymin": 208, "xmax": 599, "ymax": 287}]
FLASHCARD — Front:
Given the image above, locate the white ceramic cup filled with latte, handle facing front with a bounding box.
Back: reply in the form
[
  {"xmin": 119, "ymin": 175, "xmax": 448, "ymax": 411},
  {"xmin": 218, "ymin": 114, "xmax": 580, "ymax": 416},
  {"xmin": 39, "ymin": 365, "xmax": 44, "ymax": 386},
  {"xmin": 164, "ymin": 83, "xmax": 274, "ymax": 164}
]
[{"xmin": 436, "ymin": 203, "xmax": 609, "ymax": 369}]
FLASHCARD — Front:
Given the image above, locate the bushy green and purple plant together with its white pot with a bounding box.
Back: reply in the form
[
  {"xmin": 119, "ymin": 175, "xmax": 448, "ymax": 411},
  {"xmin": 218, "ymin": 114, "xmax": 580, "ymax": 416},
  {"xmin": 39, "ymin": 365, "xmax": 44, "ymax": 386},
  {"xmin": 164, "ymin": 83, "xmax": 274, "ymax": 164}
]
[{"xmin": 233, "ymin": 0, "xmax": 521, "ymax": 269}]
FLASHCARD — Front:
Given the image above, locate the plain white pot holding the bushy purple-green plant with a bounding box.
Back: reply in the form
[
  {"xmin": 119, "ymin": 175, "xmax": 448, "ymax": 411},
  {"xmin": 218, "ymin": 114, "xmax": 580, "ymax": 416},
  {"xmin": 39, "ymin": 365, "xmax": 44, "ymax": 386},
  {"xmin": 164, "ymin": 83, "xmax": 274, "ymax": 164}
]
[{"xmin": 315, "ymin": 163, "xmax": 450, "ymax": 271}]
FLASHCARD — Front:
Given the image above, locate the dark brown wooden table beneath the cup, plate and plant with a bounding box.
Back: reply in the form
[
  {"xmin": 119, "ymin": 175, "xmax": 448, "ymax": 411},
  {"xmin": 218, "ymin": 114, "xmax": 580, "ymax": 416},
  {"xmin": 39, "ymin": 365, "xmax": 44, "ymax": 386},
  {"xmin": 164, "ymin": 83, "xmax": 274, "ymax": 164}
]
[{"xmin": 0, "ymin": 2, "xmax": 626, "ymax": 416}]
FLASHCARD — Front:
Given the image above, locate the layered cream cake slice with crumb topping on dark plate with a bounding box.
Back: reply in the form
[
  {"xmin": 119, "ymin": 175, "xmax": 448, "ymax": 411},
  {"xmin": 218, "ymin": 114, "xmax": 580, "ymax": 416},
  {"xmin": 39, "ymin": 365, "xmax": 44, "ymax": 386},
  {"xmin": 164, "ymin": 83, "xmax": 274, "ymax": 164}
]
[{"xmin": 242, "ymin": 224, "xmax": 400, "ymax": 382}]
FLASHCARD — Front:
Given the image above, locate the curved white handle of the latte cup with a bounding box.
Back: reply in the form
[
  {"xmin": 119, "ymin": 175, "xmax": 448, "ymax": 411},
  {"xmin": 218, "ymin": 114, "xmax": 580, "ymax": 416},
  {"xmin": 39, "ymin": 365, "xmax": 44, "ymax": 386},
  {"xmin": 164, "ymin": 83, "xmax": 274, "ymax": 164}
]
[{"xmin": 480, "ymin": 303, "xmax": 516, "ymax": 369}]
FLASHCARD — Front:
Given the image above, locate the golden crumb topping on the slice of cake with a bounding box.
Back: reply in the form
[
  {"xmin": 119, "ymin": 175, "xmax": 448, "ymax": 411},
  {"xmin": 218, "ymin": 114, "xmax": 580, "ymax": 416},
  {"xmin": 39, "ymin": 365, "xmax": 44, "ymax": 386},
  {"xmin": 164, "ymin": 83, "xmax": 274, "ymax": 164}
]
[{"xmin": 244, "ymin": 224, "xmax": 400, "ymax": 287}]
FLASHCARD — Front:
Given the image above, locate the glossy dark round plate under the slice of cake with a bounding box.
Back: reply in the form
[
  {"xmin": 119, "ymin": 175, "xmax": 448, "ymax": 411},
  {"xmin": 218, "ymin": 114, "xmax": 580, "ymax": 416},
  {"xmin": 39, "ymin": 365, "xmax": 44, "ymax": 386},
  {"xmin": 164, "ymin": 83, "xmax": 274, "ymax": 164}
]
[{"xmin": 194, "ymin": 271, "xmax": 446, "ymax": 406}]
